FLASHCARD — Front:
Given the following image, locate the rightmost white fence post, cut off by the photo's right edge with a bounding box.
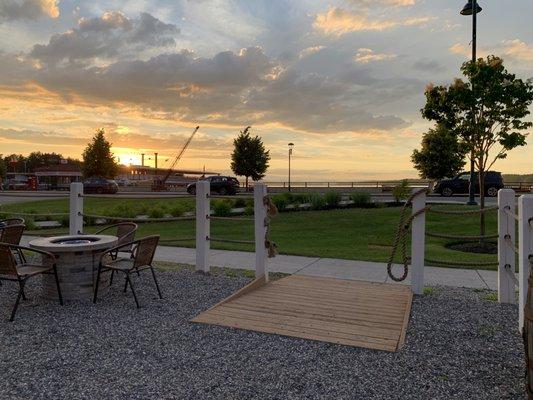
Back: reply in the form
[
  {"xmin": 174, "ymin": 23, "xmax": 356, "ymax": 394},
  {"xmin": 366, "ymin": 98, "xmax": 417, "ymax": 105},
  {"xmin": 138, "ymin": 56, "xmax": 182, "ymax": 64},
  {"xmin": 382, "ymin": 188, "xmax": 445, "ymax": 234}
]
[{"xmin": 518, "ymin": 195, "xmax": 533, "ymax": 332}]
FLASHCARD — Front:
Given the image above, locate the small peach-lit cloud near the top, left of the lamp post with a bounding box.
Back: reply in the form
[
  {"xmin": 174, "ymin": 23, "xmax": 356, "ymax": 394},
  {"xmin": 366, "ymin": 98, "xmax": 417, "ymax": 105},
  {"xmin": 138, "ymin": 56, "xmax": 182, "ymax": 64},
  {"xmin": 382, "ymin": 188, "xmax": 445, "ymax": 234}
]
[{"xmin": 313, "ymin": 6, "xmax": 396, "ymax": 36}]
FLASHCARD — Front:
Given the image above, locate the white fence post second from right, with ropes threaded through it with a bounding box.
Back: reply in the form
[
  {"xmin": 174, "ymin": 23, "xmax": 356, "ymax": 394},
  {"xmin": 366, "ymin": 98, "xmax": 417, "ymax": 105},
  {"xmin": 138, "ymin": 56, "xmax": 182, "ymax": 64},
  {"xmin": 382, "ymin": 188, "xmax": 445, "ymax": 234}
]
[{"xmin": 498, "ymin": 189, "xmax": 516, "ymax": 303}]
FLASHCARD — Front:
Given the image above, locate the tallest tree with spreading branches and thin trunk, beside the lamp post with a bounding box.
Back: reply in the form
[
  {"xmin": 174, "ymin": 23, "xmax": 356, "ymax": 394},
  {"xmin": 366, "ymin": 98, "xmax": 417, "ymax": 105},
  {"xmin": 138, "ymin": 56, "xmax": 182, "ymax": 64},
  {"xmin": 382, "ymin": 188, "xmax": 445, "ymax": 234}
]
[{"xmin": 421, "ymin": 56, "xmax": 533, "ymax": 236}]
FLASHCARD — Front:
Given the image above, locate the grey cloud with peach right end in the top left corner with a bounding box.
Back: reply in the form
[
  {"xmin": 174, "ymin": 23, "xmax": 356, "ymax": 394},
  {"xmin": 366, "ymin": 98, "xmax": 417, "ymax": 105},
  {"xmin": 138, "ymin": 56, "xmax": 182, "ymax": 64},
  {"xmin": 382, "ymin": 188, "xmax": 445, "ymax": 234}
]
[{"xmin": 0, "ymin": 0, "xmax": 59, "ymax": 21}]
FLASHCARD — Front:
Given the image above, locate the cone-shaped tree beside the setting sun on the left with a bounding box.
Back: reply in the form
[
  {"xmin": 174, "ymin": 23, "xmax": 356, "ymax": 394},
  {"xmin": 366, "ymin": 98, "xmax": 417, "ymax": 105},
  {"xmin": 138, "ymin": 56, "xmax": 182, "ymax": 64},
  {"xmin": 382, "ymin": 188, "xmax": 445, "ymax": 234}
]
[{"xmin": 82, "ymin": 129, "xmax": 118, "ymax": 178}]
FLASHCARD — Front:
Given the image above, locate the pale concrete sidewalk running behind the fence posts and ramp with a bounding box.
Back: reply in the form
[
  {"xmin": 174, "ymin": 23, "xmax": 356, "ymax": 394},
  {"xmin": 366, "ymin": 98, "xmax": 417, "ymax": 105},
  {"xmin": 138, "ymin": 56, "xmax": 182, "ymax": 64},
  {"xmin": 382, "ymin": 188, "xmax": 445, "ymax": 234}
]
[{"xmin": 155, "ymin": 246, "xmax": 498, "ymax": 290}]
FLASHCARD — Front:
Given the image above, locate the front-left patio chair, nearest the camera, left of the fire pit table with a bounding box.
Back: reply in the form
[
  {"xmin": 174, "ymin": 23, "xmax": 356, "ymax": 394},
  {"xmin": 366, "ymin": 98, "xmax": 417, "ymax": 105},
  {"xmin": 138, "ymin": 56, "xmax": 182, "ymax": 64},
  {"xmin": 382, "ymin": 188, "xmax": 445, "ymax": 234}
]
[{"xmin": 0, "ymin": 243, "xmax": 63, "ymax": 321}]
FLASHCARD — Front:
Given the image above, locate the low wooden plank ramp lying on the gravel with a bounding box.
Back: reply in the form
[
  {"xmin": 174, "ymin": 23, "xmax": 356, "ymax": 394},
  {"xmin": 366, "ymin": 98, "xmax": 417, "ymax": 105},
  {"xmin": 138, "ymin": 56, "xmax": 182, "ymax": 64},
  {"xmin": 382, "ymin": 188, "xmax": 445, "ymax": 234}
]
[{"xmin": 192, "ymin": 275, "xmax": 412, "ymax": 351}]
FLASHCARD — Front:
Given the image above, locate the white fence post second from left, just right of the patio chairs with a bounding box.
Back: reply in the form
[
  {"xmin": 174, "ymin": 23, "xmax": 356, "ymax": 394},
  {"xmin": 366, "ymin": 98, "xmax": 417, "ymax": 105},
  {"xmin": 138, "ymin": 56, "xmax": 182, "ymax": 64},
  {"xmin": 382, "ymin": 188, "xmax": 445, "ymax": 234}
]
[{"xmin": 196, "ymin": 181, "xmax": 211, "ymax": 273}]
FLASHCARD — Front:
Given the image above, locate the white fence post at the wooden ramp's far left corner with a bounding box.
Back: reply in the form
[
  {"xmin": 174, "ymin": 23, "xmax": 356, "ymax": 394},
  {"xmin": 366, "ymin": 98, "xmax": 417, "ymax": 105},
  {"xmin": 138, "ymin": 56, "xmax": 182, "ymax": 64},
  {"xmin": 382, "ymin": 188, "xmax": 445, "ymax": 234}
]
[{"xmin": 254, "ymin": 183, "xmax": 268, "ymax": 280}]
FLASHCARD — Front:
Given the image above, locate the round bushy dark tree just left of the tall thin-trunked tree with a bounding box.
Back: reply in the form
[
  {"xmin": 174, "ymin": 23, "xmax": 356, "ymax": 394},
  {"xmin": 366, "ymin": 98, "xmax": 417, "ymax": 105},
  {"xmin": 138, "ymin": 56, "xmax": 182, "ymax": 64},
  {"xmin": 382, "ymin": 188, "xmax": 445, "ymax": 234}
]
[{"xmin": 411, "ymin": 124, "xmax": 466, "ymax": 180}]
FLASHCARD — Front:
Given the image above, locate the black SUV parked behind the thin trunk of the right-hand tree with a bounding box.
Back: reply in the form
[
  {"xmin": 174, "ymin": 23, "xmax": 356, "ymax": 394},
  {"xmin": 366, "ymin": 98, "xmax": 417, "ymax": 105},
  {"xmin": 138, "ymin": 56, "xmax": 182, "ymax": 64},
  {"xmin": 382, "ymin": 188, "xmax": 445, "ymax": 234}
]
[{"xmin": 433, "ymin": 171, "xmax": 504, "ymax": 197}]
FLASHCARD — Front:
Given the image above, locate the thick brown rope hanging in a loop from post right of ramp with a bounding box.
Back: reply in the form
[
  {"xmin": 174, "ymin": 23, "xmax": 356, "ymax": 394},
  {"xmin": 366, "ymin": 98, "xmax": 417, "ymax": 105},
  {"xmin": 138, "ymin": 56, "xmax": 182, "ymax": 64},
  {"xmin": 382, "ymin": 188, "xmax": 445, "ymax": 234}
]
[{"xmin": 387, "ymin": 188, "xmax": 430, "ymax": 282}]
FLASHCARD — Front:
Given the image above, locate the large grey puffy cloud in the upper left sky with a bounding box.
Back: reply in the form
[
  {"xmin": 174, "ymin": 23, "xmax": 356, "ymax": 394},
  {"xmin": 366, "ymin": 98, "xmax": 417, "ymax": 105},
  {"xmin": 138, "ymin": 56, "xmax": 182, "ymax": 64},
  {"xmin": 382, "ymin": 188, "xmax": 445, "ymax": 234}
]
[{"xmin": 30, "ymin": 11, "xmax": 179, "ymax": 64}]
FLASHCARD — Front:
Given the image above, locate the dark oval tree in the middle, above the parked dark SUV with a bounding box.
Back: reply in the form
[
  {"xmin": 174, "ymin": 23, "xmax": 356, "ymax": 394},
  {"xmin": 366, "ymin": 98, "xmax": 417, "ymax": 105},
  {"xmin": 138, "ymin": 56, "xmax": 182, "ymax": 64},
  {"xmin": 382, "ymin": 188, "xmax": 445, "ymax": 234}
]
[{"xmin": 231, "ymin": 126, "xmax": 270, "ymax": 188}]
